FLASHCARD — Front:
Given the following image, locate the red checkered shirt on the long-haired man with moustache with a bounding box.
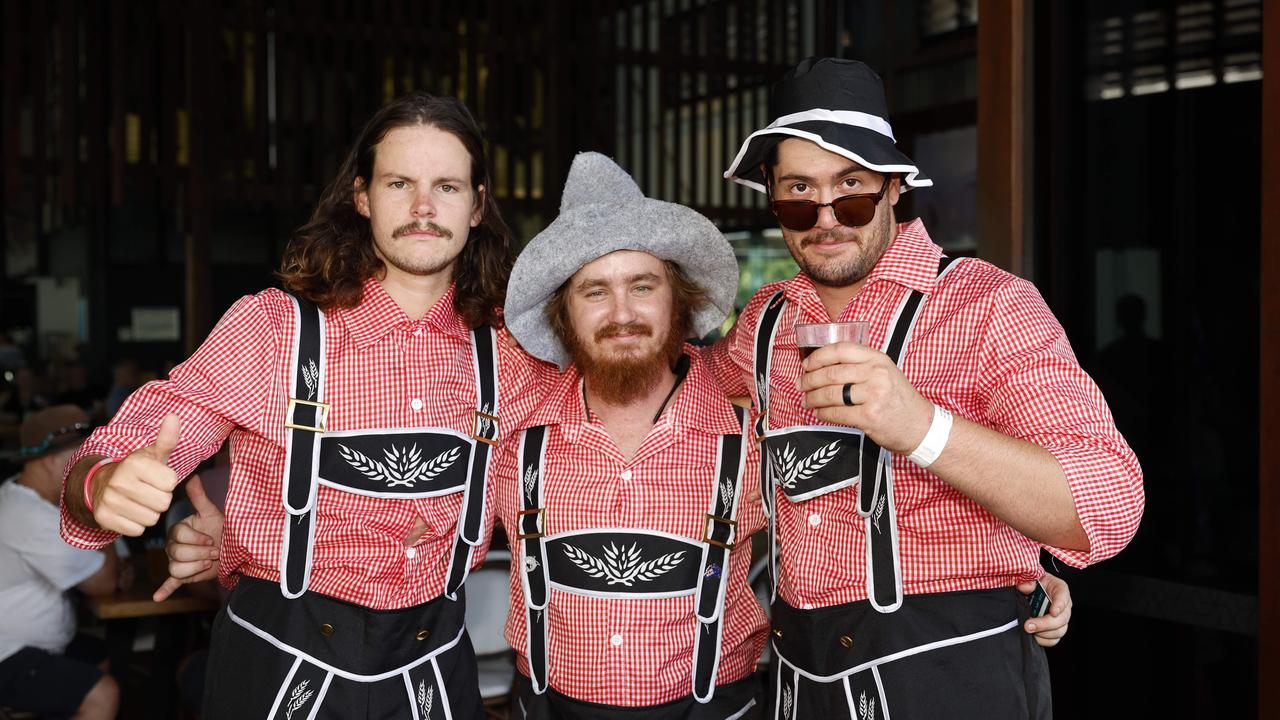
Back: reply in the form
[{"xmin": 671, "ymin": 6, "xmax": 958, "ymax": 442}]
[{"xmin": 63, "ymin": 279, "xmax": 543, "ymax": 610}]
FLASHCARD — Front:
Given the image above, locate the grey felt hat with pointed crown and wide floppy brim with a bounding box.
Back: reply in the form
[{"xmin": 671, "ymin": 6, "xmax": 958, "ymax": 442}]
[{"xmin": 503, "ymin": 152, "xmax": 737, "ymax": 368}]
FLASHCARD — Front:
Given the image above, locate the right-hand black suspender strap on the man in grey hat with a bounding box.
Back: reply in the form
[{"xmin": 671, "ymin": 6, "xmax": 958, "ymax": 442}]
[{"xmin": 692, "ymin": 406, "xmax": 750, "ymax": 702}]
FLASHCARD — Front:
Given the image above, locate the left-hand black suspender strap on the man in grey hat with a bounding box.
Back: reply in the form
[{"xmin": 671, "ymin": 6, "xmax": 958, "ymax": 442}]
[{"xmin": 516, "ymin": 425, "xmax": 549, "ymax": 694}]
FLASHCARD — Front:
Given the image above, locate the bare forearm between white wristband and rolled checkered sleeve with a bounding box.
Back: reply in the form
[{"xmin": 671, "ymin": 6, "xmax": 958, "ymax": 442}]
[{"xmin": 929, "ymin": 415, "xmax": 1089, "ymax": 551}]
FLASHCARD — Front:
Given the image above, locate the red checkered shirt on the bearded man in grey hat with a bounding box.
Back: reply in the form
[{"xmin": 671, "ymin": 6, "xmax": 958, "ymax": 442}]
[{"xmin": 494, "ymin": 348, "xmax": 768, "ymax": 707}]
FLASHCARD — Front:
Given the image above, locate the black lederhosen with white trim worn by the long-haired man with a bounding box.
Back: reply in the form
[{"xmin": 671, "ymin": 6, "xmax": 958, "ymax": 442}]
[{"xmin": 205, "ymin": 299, "xmax": 498, "ymax": 720}]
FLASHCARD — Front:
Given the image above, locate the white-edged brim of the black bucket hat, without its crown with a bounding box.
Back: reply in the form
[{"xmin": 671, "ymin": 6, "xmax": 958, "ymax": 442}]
[{"xmin": 724, "ymin": 120, "xmax": 933, "ymax": 192}]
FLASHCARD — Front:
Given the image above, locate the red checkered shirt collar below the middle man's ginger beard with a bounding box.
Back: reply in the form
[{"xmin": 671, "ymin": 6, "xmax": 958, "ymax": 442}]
[{"xmin": 525, "ymin": 345, "xmax": 741, "ymax": 442}]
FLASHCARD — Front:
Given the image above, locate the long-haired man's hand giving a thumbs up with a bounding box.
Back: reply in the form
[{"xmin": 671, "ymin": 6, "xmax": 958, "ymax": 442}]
[{"xmin": 90, "ymin": 415, "xmax": 182, "ymax": 537}]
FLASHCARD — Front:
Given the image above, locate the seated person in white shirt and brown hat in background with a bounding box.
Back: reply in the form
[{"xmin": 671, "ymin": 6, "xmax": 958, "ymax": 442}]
[{"xmin": 0, "ymin": 405, "xmax": 119, "ymax": 720}]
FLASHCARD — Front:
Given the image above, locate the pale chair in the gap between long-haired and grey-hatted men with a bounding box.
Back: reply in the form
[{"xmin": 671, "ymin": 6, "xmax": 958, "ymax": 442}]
[{"xmin": 467, "ymin": 550, "xmax": 516, "ymax": 717}]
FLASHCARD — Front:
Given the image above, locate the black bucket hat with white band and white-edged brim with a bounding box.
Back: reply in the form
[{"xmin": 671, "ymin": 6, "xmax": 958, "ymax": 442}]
[{"xmin": 724, "ymin": 58, "xmax": 933, "ymax": 192}]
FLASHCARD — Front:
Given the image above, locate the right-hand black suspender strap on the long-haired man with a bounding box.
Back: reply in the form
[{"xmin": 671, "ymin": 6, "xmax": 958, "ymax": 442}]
[{"xmin": 444, "ymin": 325, "xmax": 499, "ymax": 600}]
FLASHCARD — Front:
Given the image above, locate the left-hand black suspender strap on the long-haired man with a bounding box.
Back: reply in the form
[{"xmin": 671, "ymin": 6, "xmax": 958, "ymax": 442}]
[{"xmin": 280, "ymin": 295, "xmax": 329, "ymax": 598}]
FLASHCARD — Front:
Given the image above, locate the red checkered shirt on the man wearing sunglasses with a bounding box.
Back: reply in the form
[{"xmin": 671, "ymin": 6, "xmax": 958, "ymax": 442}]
[{"xmin": 708, "ymin": 220, "xmax": 1143, "ymax": 607}]
